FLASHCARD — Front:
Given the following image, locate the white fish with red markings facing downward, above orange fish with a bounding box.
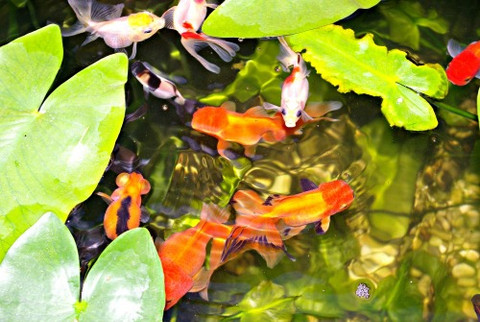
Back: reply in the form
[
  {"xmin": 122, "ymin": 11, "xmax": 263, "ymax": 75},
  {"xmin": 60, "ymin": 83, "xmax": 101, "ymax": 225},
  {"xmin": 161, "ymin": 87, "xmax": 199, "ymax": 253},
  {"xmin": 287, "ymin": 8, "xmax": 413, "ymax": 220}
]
[{"xmin": 263, "ymin": 37, "xmax": 342, "ymax": 128}]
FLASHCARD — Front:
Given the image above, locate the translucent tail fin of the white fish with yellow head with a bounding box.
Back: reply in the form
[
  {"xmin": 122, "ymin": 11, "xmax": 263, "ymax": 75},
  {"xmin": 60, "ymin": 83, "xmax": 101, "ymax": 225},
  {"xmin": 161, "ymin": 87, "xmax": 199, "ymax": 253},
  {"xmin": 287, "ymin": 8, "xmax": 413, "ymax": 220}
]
[{"xmin": 68, "ymin": 0, "xmax": 124, "ymax": 26}]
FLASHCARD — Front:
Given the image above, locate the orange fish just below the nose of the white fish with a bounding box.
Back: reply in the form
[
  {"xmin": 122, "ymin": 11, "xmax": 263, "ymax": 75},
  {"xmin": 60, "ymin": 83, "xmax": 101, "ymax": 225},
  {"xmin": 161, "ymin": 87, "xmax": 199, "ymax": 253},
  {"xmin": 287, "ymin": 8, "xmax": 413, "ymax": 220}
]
[{"xmin": 192, "ymin": 106, "xmax": 287, "ymax": 159}]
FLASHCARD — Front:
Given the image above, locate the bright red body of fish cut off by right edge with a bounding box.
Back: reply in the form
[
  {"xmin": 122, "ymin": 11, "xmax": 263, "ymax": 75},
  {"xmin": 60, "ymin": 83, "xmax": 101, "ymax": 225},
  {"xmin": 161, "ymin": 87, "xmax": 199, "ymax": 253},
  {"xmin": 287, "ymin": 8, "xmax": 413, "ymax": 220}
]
[{"xmin": 446, "ymin": 51, "xmax": 480, "ymax": 86}]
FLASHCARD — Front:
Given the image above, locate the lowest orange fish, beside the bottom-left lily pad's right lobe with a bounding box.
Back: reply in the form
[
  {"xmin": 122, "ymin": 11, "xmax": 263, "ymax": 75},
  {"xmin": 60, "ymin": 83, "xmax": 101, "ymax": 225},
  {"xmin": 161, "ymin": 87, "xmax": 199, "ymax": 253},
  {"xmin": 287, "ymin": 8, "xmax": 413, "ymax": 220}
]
[{"xmin": 157, "ymin": 204, "xmax": 281, "ymax": 310}]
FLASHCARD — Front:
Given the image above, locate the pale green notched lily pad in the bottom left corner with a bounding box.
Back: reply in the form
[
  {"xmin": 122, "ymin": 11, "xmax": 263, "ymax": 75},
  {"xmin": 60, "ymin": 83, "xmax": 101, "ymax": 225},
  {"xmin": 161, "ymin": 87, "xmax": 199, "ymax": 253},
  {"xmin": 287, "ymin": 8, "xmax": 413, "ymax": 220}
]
[{"xmin": 0, "ymin": 213, "xmax": 165, "ymax": 321}]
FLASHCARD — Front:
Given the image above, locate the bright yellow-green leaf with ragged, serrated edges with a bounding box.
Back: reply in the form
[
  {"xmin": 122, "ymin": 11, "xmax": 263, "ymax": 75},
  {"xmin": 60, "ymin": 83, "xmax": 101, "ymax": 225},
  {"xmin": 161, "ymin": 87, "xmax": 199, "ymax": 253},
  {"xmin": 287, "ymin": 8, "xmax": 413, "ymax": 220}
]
[{"xmin": 287, "ymin": 25, "xmax": 448, "ymax": 131}]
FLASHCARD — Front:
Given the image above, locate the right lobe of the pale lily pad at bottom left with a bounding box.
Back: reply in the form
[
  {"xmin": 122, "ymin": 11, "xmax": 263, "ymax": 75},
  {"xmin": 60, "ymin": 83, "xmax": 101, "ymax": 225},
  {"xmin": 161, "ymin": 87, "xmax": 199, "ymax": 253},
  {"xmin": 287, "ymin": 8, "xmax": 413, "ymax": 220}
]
[{"xmin": 79, "ymin": 228, "xmax": 165, "ymax": 321}]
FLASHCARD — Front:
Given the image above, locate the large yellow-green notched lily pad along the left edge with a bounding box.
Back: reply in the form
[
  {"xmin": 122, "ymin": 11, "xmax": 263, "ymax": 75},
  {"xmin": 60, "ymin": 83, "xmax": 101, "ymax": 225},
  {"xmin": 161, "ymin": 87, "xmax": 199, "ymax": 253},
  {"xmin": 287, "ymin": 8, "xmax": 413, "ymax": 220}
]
[{"xmin": 0, "ymin": 25, "xmax": 128, "ymax": 259}]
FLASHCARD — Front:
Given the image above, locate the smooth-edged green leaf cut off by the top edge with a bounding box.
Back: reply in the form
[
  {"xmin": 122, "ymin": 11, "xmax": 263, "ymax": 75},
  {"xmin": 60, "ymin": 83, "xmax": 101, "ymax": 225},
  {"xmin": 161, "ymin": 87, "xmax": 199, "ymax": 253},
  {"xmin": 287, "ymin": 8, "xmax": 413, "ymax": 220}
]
[{"xmin": 202, "ymin": 0, "xmax": 380, "ymax": 38}]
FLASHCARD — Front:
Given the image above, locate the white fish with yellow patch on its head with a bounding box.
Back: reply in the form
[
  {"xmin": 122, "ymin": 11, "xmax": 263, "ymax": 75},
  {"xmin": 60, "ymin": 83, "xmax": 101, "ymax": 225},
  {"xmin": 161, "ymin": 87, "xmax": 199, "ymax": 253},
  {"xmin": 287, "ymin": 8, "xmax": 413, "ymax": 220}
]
[{"xmin": 62, "ymin": 0, "xmax": 165, "ymax": 59}]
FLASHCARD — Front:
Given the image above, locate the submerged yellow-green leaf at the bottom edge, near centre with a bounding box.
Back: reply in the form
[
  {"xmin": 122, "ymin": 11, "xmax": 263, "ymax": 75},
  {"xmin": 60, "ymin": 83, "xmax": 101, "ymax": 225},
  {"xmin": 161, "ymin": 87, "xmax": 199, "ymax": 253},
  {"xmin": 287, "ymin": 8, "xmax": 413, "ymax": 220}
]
[{"xmin": 224, "ymin": 281, "xmax": 295, "ymax": 321}]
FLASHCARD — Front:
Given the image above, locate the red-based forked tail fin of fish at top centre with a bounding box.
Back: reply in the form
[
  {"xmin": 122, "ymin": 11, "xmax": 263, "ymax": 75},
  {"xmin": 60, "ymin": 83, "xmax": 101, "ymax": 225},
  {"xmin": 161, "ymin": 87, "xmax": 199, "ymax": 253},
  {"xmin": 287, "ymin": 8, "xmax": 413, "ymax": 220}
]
[{"xmin": 181, "ymin": 32, "xmax": 240, "ymax": 74}]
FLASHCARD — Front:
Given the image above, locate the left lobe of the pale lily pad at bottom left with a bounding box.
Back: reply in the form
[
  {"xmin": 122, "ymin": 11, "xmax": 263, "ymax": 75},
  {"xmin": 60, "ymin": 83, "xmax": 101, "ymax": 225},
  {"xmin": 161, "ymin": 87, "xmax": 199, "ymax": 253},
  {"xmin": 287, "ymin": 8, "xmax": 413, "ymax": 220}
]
[{"xmin": 0, "ymin": 213, "xmax": 80, "ymax": 321}]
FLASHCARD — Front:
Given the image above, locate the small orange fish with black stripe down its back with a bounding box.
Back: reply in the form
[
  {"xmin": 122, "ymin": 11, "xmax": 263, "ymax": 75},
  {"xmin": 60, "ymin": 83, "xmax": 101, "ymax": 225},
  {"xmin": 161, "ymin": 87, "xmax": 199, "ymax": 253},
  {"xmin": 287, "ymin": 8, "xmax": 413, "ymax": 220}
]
[{"xmin": 97, "ymin": 172, "xmax": 150, "ymax": 240}]
